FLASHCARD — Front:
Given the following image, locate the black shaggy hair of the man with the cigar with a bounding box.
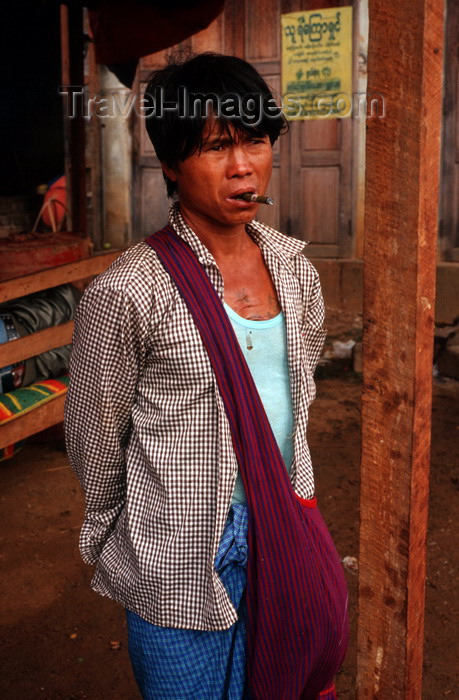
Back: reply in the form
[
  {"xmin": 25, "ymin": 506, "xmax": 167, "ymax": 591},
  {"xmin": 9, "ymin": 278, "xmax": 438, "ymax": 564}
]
[{"xmin": 145, "ymin": 53, "xmax": 288, "ymax": 197}]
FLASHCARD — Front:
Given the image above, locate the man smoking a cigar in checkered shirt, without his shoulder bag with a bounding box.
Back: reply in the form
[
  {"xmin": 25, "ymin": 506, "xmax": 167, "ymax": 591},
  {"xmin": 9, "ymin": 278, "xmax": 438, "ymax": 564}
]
[{"xmin": 66, "ymin": 54, "xmax": 344, "ymax": 700}]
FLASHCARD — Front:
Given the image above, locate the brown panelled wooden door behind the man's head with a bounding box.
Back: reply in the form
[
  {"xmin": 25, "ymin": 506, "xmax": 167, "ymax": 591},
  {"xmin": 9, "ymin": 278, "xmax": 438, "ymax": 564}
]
[{"xmin": 135, "ymin": 0, "xmax": 352, "ymax": 257}]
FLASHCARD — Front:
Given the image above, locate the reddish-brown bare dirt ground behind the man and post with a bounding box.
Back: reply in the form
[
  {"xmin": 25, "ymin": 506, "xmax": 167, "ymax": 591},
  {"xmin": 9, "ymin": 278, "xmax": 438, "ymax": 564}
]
[{"xmin": 0, "ymin": 371, "xmax": 459, "ymax": 700}]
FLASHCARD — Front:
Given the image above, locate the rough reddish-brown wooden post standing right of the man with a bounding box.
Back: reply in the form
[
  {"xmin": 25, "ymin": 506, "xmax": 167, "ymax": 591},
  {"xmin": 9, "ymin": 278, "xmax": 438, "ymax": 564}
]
[{"xmin": 357, "ymin": 0, "xmax": 444, "ymax": 700}]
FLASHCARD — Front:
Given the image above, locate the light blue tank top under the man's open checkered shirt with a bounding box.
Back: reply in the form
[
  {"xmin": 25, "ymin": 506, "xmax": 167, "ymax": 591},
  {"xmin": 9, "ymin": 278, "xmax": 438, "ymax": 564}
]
[{"xmin": 225, "ymin": 304, "xmax": 293, "ymax": 503}]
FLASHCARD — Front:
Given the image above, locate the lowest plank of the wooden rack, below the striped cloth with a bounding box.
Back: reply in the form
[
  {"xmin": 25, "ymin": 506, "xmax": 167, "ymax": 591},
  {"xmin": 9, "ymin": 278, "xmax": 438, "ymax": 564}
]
[{"xmin": 0, "ymin": 392, "xmax": 67, "ymax": 450}]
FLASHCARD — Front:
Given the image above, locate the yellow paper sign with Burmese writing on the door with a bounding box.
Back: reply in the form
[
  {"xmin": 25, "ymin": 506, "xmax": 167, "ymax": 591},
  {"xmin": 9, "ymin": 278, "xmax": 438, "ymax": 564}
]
[{"xmin": 281, "ymin": 7, "xmax": 352, "ymax": 119}]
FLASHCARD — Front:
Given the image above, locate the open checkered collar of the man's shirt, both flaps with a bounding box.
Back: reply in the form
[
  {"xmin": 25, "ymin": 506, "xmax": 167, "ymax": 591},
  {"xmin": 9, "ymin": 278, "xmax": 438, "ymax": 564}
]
[{"xmin": 169, "ymin": 202, "xmax": 308, "ymax": 267}]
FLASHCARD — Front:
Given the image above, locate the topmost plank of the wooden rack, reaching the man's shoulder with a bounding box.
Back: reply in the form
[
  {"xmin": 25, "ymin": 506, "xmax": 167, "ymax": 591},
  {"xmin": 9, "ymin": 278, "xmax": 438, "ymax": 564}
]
[{"xmin": 0, "ymin": 250, "xmax": 123, "ymax": 304}]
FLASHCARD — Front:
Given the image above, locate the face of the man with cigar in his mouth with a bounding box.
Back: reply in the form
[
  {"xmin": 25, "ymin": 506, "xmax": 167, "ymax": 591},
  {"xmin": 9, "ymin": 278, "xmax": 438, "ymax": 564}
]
[{"xmin": 163, "ymin": 118, "xmax": 272, "ymax": 227}]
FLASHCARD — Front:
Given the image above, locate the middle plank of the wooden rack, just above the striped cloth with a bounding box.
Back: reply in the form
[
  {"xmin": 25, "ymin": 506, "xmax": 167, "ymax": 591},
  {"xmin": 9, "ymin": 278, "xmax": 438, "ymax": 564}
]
[{"xmin": 0, "ymin": 321, "xmax": 74, "ymax": 367}]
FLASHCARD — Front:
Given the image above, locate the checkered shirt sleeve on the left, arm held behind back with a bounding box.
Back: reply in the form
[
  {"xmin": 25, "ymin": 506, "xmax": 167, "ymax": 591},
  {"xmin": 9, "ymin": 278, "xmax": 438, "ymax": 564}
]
[{"xmin": 65, "ymin": 287, "xmax": 145, "ymax": 563}]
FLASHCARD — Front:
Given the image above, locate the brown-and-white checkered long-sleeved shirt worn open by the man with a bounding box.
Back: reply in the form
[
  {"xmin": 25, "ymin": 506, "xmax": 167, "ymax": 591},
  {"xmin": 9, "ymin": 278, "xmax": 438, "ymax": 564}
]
[{"xmin": 65, "ymin": 205, "xmax": 326, "ymax": 630}]
